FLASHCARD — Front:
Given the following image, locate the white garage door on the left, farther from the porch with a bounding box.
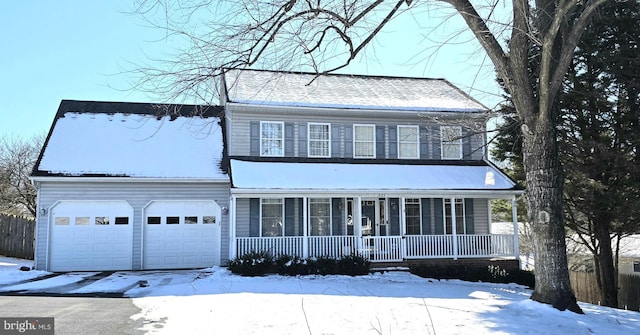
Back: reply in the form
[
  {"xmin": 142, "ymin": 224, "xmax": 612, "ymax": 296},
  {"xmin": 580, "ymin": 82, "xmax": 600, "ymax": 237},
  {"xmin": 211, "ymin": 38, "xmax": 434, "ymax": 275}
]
[{"xmin": 49, "ymin": 201, "xmax": 133, "ymax": 271}]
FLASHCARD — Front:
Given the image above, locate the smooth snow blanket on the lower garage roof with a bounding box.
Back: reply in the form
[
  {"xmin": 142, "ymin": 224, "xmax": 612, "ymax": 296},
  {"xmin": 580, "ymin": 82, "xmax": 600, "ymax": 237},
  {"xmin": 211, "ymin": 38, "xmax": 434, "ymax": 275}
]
[{"xmin": 34, "ymin": 101, "xmax": 228, "ymax": 180}]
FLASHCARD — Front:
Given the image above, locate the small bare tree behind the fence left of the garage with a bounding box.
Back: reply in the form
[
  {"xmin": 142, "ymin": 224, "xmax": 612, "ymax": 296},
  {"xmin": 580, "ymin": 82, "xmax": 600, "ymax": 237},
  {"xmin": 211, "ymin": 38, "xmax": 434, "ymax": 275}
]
[{"xmin": 0, "ymin": 136, "xmax": 44, "ymax": 217}]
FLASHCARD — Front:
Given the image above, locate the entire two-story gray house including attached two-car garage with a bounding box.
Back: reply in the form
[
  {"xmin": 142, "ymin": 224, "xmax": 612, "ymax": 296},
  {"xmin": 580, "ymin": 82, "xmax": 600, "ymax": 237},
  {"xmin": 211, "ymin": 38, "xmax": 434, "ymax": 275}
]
[{"xmin": 32, "ymin": 70, "xmax": 522, "ymax": 271}]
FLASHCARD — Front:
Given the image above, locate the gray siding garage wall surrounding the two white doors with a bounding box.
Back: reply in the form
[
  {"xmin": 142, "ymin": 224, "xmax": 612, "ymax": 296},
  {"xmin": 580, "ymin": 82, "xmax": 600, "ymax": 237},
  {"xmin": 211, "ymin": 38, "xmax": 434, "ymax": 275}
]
[{"xmin": 34, "ymin": 182, "xmax": 229, "ymax": 270}]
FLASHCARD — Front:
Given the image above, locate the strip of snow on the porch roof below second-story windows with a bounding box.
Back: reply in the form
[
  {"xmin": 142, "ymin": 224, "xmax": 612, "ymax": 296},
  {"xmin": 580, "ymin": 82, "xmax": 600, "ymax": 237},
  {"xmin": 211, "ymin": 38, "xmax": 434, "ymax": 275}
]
[{"xmin": 231, "ymin": 159, "xmax": 516, "ymax": 191}]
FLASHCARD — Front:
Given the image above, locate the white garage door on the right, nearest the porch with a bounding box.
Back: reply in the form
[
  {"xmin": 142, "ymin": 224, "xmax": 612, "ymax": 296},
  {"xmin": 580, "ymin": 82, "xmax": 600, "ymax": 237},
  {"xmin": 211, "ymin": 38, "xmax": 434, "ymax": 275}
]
[{"xmin": 142, "ymin": 201, "xmax": 221, "ymax": 269}]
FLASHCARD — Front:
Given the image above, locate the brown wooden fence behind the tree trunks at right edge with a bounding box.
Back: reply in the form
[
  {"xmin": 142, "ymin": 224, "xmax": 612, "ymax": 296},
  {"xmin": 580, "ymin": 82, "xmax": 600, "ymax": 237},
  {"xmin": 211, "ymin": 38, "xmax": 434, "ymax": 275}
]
[{"xmin": 570, "ymin": 272, "xmax": 640, "ymax": 311}]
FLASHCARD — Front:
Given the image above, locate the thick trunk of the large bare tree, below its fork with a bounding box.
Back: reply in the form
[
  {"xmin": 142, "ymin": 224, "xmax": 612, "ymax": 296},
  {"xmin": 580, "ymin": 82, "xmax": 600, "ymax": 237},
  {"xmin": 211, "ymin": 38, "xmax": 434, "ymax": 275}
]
[{"xmin": 522, "ymin": 118, "xmax": 582, "ymax": 314}]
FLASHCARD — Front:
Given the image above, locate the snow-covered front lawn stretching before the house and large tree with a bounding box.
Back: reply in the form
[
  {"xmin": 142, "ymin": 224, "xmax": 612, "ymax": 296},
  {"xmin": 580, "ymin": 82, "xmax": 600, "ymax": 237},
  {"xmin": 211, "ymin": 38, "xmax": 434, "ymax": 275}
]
[{"xmin": 0, "ymin": 258, "xmax": 640, "ymax": 335}]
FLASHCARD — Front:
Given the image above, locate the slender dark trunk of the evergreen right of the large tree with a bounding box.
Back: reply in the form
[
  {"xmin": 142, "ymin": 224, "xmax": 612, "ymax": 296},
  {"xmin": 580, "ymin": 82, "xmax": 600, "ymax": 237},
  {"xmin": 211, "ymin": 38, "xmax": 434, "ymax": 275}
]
[{"xmin": 594, "ymin": 215, "xmax": 618, "ymax": 308}]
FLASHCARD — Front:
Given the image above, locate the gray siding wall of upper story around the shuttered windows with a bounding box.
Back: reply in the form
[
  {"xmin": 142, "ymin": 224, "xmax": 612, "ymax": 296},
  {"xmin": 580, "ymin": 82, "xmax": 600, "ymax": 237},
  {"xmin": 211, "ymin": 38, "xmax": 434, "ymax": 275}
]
[{"xmin": 227, "ymin": 107, "xmax": 486, "ymax": 160}]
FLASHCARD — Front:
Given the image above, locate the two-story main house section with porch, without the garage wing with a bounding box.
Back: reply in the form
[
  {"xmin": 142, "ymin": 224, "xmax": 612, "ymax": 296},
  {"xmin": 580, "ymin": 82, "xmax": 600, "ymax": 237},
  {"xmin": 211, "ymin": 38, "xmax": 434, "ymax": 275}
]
[{"xmin": 221, "ymin": 70, "xmax": 522, "ymax": 263}]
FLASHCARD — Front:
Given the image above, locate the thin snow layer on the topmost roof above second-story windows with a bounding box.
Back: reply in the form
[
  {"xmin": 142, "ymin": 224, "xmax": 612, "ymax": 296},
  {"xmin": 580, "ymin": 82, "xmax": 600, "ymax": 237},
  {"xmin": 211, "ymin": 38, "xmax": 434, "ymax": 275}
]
[{"xmin": 224, "ymin": 70, "xmax": 487, "ymax": 112}]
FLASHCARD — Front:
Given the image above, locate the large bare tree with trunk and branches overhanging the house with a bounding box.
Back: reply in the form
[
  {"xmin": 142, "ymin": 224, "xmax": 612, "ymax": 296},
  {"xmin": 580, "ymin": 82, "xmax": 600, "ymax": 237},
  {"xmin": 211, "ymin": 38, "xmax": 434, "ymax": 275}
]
[{"xmin": 129, "ymin": 0, "xmax": 607, "ymax": 313}]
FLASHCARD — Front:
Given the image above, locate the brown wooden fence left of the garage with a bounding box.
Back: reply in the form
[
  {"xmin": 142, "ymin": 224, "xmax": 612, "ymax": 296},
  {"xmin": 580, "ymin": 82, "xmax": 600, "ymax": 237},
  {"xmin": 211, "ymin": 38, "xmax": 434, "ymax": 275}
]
[{"xmin": 0, "ymin": 214, "xmax": 36, "ymax": 259}]
